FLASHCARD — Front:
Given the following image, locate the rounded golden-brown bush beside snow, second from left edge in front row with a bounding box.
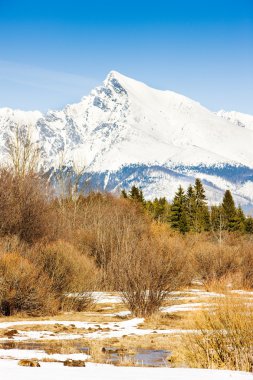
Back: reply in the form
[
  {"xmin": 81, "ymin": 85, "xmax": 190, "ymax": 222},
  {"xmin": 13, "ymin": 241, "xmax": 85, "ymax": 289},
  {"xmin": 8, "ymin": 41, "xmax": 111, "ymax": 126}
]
[{"xmin": 30, "ymin": 241, "xmax": 98, "ymax": 311}]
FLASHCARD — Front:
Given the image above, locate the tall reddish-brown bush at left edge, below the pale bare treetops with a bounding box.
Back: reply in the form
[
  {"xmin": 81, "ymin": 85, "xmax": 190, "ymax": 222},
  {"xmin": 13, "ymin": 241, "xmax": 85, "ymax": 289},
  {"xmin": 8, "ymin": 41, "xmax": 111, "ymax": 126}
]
[{"xmin": 0, "ymin": 169, "xmax": 57, "ymax": 243}]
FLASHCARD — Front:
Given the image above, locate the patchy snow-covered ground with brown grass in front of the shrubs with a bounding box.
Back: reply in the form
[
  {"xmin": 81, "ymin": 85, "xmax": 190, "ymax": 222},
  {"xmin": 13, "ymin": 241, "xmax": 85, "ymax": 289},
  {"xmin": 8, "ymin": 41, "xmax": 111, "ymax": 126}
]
[{"xmin": 0, "ymin": 289, "xmax": 253, "ymax": 380}]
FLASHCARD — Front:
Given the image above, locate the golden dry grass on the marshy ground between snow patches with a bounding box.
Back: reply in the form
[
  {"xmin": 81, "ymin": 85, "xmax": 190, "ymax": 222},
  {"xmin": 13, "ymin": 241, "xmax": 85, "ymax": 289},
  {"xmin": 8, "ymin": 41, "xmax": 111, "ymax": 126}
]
[{"xmin": 0, "ymin": 293, "xmax": 253, "ymax": 370}]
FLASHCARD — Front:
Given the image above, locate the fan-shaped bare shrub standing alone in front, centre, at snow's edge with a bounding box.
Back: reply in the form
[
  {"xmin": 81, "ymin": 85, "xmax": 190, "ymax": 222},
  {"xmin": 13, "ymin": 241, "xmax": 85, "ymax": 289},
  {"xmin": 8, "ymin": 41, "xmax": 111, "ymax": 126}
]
[{"xmin": 111, "ymin": 236, "xmax": 192, "ymax": 317}]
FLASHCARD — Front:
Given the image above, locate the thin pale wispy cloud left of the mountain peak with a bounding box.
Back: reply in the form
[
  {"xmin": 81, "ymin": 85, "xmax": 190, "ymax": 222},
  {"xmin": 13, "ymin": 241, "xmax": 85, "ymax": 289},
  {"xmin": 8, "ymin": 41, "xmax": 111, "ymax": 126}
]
[{"xmin": 0, "ymin": 60, "xmax": 99, "ymax": 110}]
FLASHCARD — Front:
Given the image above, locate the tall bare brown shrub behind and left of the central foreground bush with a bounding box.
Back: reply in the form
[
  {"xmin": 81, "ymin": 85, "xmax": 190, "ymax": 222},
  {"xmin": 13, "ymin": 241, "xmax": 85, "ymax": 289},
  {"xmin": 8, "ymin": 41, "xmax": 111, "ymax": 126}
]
[{"xmin": 69, "ymin": 194, "xmax": 150, "ymax": 286}]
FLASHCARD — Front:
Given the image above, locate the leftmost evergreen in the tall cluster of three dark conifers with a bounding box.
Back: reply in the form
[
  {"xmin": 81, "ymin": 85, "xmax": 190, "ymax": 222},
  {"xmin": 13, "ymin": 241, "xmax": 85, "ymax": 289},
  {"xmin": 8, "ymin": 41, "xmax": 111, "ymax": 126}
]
[{"xmin": 171, "ymin": 186, "xmax": 189, "ymax": 234}]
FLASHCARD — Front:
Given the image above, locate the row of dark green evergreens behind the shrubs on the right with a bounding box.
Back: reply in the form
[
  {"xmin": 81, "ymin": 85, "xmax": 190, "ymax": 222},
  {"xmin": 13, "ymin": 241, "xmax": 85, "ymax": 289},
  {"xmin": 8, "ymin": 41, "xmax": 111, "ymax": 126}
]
[{"xmin": 121, "ymin": 179, "xmax": 253, "ymax": 234}]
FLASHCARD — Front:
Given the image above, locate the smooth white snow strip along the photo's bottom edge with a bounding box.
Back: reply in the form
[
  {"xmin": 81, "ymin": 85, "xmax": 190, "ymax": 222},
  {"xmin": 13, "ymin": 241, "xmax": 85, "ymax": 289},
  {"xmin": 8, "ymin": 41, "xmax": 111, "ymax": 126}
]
[{"xmin": 0, "ymin": 360, "xmax": 253, "ymax": 380}]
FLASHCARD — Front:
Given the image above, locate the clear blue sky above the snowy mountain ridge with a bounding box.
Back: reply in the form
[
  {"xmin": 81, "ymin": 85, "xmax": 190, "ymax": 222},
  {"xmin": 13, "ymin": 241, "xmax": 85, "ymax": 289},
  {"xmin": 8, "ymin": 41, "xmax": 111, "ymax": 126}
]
[{"xmin": 0, "ymin": 0, "xmax": 253, "ymax": 114}]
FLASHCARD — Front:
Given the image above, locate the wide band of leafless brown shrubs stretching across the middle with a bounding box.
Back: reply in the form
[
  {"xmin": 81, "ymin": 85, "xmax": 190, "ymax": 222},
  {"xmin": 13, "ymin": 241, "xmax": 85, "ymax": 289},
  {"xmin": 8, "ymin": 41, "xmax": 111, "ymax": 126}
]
[{"xmin": 0, "ymin": 169, "xmax": 253, "ymax": 316}]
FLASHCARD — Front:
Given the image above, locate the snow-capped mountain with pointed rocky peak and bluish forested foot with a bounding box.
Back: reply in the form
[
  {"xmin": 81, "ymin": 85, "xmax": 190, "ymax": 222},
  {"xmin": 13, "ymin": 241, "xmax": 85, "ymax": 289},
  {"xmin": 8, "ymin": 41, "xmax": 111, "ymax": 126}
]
[{"xmin": 0, "ymin": 71, "xmax": 253, "ymax": 212}]
